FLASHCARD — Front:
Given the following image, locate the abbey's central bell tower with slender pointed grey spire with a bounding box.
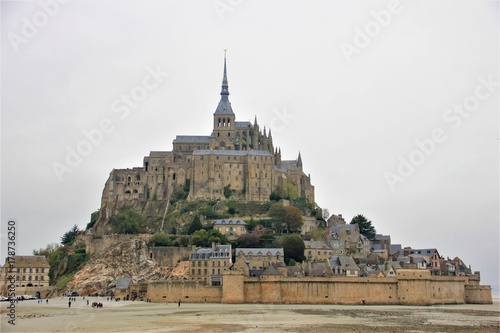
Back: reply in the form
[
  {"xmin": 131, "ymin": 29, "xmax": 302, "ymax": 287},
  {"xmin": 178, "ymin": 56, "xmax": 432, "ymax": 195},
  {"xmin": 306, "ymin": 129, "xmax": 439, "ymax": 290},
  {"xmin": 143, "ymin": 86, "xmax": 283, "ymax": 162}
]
[{"xmin": 210, "ymin": 50, "xmax": 236, "ymax": 150}]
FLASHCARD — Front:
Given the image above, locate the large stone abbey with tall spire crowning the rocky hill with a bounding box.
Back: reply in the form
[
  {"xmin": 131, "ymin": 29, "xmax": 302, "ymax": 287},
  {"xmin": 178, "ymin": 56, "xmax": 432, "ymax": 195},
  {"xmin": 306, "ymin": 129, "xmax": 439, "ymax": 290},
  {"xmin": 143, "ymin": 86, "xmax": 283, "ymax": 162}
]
[{"xmin": 102, "ymin": 56, "xmax": 314, "ymax": 211}]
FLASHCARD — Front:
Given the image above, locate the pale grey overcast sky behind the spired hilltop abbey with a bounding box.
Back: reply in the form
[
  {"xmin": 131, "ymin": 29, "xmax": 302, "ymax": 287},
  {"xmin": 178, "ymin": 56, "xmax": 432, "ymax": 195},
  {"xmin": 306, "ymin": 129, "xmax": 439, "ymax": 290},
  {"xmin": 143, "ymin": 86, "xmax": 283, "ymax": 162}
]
[{"xmin": 1, "ymin": 0, "xmax": 500, "ymax": 285}]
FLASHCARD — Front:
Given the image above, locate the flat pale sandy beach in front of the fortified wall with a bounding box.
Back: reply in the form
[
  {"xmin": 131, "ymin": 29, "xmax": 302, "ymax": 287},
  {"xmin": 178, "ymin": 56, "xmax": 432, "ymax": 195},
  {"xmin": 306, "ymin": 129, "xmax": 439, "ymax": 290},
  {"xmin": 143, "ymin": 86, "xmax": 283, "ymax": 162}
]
[{"xmin": 1, "ymin": 297, "xmax": 500, "ymax": 333}]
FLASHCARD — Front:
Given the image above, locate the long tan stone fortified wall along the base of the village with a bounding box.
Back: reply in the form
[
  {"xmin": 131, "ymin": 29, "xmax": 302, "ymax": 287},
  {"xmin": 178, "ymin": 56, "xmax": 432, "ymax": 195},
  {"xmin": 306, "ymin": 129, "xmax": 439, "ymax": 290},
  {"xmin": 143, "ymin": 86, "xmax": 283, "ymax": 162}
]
[{"xmin": 147, "ymin": 270, "xmax": 492, "ymax": 305}]
